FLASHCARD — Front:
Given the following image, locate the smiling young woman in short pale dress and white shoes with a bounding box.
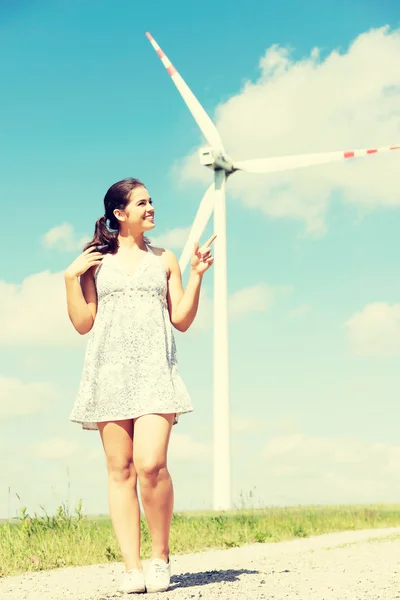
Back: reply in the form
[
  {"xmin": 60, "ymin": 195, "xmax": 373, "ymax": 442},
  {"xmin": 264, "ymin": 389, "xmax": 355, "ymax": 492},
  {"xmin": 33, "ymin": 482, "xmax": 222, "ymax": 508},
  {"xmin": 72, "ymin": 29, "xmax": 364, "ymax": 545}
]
[{"xmin": 64, "ymin": 179, "xmax": 215, "ymax": 593}]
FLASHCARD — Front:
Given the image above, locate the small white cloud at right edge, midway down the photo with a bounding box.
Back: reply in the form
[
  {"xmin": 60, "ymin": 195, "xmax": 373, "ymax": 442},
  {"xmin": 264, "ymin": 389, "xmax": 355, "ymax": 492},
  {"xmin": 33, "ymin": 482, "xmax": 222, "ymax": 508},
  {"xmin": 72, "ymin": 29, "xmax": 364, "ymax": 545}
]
[{"xmin": 345, "ymin": 302, "xmax": 400, "ymax": 356}]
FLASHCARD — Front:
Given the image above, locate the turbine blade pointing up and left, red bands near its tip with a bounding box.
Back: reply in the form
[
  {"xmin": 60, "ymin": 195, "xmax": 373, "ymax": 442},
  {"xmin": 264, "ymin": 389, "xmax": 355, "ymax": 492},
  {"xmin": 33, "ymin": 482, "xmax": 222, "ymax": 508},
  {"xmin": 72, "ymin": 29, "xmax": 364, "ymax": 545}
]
[{"xmin": 146, "ymin": 32, "xmax": 225, "ymax": 152}]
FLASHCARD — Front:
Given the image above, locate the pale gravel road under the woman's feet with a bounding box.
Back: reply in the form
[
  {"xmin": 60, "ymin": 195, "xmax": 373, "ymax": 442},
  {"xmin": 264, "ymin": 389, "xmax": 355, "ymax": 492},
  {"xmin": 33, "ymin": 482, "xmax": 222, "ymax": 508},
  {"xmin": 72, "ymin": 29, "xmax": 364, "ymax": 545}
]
[{"xmin": 0, "ymin": 527, "xmax": 400, "ymax": 600}]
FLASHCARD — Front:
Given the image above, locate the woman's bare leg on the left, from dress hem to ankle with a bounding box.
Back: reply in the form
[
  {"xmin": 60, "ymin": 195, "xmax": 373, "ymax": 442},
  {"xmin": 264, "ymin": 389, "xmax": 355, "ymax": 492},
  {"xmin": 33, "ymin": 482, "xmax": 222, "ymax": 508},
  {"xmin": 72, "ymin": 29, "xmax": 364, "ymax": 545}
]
[{"xmin": 98, "ymin": 419, "xmax": 142, "ymax": 571}]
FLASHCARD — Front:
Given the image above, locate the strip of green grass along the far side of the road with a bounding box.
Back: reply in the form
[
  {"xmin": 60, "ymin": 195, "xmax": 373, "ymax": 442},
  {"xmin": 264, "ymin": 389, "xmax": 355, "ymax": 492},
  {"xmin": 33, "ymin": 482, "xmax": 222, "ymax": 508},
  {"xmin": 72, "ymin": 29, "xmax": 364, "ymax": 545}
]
[{"xmin": 0, "ymin": 504, "xmax": 400, "ymax": 576}]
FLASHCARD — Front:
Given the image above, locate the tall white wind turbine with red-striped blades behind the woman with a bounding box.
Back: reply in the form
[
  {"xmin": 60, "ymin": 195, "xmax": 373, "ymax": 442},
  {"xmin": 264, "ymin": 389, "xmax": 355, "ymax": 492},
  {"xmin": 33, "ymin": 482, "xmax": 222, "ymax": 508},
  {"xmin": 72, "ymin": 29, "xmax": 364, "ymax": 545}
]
[{"xmin": 146, "ymin": 33, "xmax": 400, "ymax": 510}]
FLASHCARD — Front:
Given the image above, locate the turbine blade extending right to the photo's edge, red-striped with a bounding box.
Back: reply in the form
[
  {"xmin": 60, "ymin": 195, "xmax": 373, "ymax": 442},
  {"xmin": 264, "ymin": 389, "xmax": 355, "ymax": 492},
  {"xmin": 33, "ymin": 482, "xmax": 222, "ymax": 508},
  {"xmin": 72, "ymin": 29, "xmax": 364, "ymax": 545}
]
[{"xmin": 234, "ymin": 146, "xmax": 400, "ymax": 173}]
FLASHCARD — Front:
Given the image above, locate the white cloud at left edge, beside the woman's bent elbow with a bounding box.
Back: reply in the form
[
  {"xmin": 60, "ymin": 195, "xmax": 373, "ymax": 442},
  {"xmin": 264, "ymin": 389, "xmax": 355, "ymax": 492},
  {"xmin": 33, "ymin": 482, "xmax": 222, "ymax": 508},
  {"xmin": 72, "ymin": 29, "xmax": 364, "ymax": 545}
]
[{"xmin": 0, "ymin": 271, "xmax": 84, "ymax": 345}]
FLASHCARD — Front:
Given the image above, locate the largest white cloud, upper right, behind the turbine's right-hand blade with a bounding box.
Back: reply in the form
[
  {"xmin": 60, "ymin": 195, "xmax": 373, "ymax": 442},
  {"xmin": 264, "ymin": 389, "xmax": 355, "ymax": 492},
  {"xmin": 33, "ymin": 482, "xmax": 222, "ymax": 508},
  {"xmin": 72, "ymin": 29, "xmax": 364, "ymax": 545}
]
[{"xmin": 179, "ymin": 27, "xmax": 400, "ymax": 235}]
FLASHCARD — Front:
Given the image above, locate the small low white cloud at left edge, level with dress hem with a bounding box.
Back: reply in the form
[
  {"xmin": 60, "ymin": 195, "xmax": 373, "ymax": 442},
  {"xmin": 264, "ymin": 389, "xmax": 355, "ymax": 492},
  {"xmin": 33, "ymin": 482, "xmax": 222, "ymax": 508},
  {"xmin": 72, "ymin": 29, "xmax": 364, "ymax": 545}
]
[{"xmin": 0, "ymin": 376, "xmax": 58, "ymax": 419}]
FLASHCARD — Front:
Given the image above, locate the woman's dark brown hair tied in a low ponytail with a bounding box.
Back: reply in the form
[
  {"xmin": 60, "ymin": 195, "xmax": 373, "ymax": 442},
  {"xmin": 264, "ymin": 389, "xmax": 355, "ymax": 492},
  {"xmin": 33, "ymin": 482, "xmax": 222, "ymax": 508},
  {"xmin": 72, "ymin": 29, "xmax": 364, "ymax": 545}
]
[{"xmin": 83, "ymin": 177, "xmax": 149, "ymax": 254}]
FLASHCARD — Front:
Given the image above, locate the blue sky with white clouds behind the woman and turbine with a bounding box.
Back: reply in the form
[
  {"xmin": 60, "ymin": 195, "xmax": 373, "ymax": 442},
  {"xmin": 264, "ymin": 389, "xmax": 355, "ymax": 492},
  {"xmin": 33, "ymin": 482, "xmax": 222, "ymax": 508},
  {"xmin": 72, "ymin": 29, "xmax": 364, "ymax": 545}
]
[{"xmin": 0, "ymin": 0, "xmax": 400, "ymax": 517}]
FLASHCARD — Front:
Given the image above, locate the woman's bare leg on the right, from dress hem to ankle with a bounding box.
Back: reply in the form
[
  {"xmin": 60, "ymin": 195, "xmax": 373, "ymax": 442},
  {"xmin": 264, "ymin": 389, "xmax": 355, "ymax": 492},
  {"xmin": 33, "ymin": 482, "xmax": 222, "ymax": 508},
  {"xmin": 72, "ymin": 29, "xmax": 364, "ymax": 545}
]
[{"xmin": 133, "ymin": 414, "xmax": 175, "ymax": 561}]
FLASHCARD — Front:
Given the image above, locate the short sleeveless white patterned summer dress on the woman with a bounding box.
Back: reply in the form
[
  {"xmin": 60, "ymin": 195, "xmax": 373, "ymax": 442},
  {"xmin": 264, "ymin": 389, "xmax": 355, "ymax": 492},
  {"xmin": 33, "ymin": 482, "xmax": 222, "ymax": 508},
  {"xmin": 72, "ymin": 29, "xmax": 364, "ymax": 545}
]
[{"xmin": 70, "ymin": 246, "xmax": 193, "ymax": 429}]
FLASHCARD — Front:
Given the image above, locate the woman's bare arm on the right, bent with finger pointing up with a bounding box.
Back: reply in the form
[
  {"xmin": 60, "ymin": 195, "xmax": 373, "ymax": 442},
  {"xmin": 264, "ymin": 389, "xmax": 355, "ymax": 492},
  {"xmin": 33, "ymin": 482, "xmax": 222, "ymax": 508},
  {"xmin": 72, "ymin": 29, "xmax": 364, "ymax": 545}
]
[{"xmin": 167, "ymin": 236, "xmax": 216, "ymax": 332}]
